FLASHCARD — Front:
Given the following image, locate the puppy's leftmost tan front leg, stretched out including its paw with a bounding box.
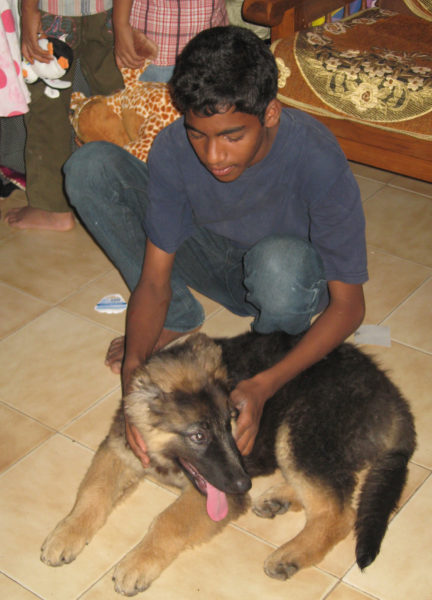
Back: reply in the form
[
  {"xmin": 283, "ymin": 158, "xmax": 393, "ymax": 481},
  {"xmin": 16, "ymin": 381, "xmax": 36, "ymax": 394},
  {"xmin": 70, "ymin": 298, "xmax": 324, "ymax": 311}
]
[{"xmin": 41, "ymin": 438, "xmax": 144, "ymax": 566}]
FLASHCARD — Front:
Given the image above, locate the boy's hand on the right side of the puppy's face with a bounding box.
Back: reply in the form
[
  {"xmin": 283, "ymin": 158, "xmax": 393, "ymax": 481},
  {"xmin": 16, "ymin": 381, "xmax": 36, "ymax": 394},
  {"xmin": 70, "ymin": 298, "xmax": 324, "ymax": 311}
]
[{"xmin": 231, "ymin": 379, "xmax": 267, "ymax": 455}]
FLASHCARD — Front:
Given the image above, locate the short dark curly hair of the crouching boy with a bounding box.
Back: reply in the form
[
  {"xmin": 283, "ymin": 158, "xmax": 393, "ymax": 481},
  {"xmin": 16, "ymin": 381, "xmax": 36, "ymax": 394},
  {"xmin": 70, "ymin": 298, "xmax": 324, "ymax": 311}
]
[{"xmin": 169, "ymin": 25, "xmax": 278, "ymax": 123}]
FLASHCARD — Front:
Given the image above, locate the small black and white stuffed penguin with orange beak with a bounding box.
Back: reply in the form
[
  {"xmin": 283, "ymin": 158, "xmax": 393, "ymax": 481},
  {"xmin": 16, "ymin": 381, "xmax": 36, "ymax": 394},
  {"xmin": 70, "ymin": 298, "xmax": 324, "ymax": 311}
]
[{"xmin": 22, "ymin": 36, "xmax": 73, "ymax": 98}]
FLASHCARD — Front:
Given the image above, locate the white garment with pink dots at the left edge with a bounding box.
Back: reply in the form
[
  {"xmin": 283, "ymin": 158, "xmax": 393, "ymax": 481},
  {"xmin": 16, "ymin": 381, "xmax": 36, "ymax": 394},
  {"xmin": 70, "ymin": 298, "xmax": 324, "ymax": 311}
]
[{"xmin": 0, "ymin": 0, "xmax": 30, "ymax": 117}]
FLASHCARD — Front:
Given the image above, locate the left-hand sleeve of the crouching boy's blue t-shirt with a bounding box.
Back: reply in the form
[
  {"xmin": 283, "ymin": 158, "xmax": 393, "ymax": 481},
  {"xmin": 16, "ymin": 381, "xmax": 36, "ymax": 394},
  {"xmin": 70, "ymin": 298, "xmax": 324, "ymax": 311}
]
[{"xmin": 145, "ymin": 131, "xmax": 193, "ymax": 253}]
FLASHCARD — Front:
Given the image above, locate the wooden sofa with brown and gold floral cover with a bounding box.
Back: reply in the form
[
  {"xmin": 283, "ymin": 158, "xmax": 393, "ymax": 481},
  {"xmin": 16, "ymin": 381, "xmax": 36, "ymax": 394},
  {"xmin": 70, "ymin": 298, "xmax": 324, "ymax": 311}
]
[{"xmin": 243, "ymin": 0, "xmax": 432, "ymax": 182}]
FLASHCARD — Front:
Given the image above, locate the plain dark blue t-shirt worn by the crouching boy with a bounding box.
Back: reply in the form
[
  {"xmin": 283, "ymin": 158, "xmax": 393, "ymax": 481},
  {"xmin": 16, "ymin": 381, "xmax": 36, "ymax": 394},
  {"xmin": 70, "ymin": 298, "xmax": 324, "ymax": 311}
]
[{"xmin": 145, "ymin": 108, "xmax": 367, "ymax": 283}]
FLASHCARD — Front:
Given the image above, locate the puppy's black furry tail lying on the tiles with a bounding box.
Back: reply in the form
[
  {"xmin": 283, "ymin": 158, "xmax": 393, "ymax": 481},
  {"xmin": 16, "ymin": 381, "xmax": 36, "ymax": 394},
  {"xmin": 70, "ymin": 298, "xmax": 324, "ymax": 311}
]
[{"xmin": 355, "ymin": 451, "xmax": 411, "ymax": 570}]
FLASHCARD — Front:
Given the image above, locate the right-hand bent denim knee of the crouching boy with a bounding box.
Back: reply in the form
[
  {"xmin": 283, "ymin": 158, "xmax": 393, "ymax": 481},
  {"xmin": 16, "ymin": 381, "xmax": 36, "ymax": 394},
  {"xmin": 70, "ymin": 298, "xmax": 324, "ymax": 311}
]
[{"xmin": 244, "ymin": 236, "xmax": 326, "ymax": 333}]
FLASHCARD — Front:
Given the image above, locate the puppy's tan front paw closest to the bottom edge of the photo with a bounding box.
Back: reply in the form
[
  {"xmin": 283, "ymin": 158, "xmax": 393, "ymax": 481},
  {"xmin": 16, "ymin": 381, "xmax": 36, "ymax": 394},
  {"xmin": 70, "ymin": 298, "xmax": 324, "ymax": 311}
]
[{"xmin": 113, "ymin": 547, "xmax": 161, "ymax": 596}]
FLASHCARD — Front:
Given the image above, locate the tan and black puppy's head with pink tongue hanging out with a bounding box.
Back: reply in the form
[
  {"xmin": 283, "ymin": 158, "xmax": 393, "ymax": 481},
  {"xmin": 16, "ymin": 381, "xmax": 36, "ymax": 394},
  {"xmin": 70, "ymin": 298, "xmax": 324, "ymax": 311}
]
[{"xmin": 124, "ymin": 334, "xmax": 251, "ymax": 520}]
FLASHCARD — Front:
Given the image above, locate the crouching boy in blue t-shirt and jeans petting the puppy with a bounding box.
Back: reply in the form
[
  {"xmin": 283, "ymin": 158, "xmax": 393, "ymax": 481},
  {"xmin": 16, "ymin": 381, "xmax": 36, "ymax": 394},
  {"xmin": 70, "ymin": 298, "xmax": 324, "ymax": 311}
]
[{"xmin": 66, "ymin": 26, "xmax": 367, "ymax": 463}]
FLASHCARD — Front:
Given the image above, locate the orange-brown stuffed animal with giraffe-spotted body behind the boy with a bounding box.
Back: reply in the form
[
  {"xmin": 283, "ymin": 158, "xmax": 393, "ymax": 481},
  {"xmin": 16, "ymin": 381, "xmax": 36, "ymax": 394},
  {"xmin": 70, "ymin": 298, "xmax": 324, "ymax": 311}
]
[{"xmin": 71, "ymin": 60, "xmax": 180, "ymax": 161}]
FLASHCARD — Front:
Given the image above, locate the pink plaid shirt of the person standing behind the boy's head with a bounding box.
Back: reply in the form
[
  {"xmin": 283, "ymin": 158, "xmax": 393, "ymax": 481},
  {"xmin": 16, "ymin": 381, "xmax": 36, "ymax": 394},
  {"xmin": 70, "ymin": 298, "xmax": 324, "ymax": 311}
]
[{"xmin": 129, "ymin": 0, "xmax": 228, "ymax": 66}]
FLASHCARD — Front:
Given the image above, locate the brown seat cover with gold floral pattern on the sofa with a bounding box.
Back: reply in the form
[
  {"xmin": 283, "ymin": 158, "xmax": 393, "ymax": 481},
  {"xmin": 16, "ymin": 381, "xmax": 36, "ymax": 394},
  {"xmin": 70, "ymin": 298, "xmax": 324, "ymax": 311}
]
[{"xmin": 273, "ymin": 9, "xmax": 432, "ymax": 139}]
